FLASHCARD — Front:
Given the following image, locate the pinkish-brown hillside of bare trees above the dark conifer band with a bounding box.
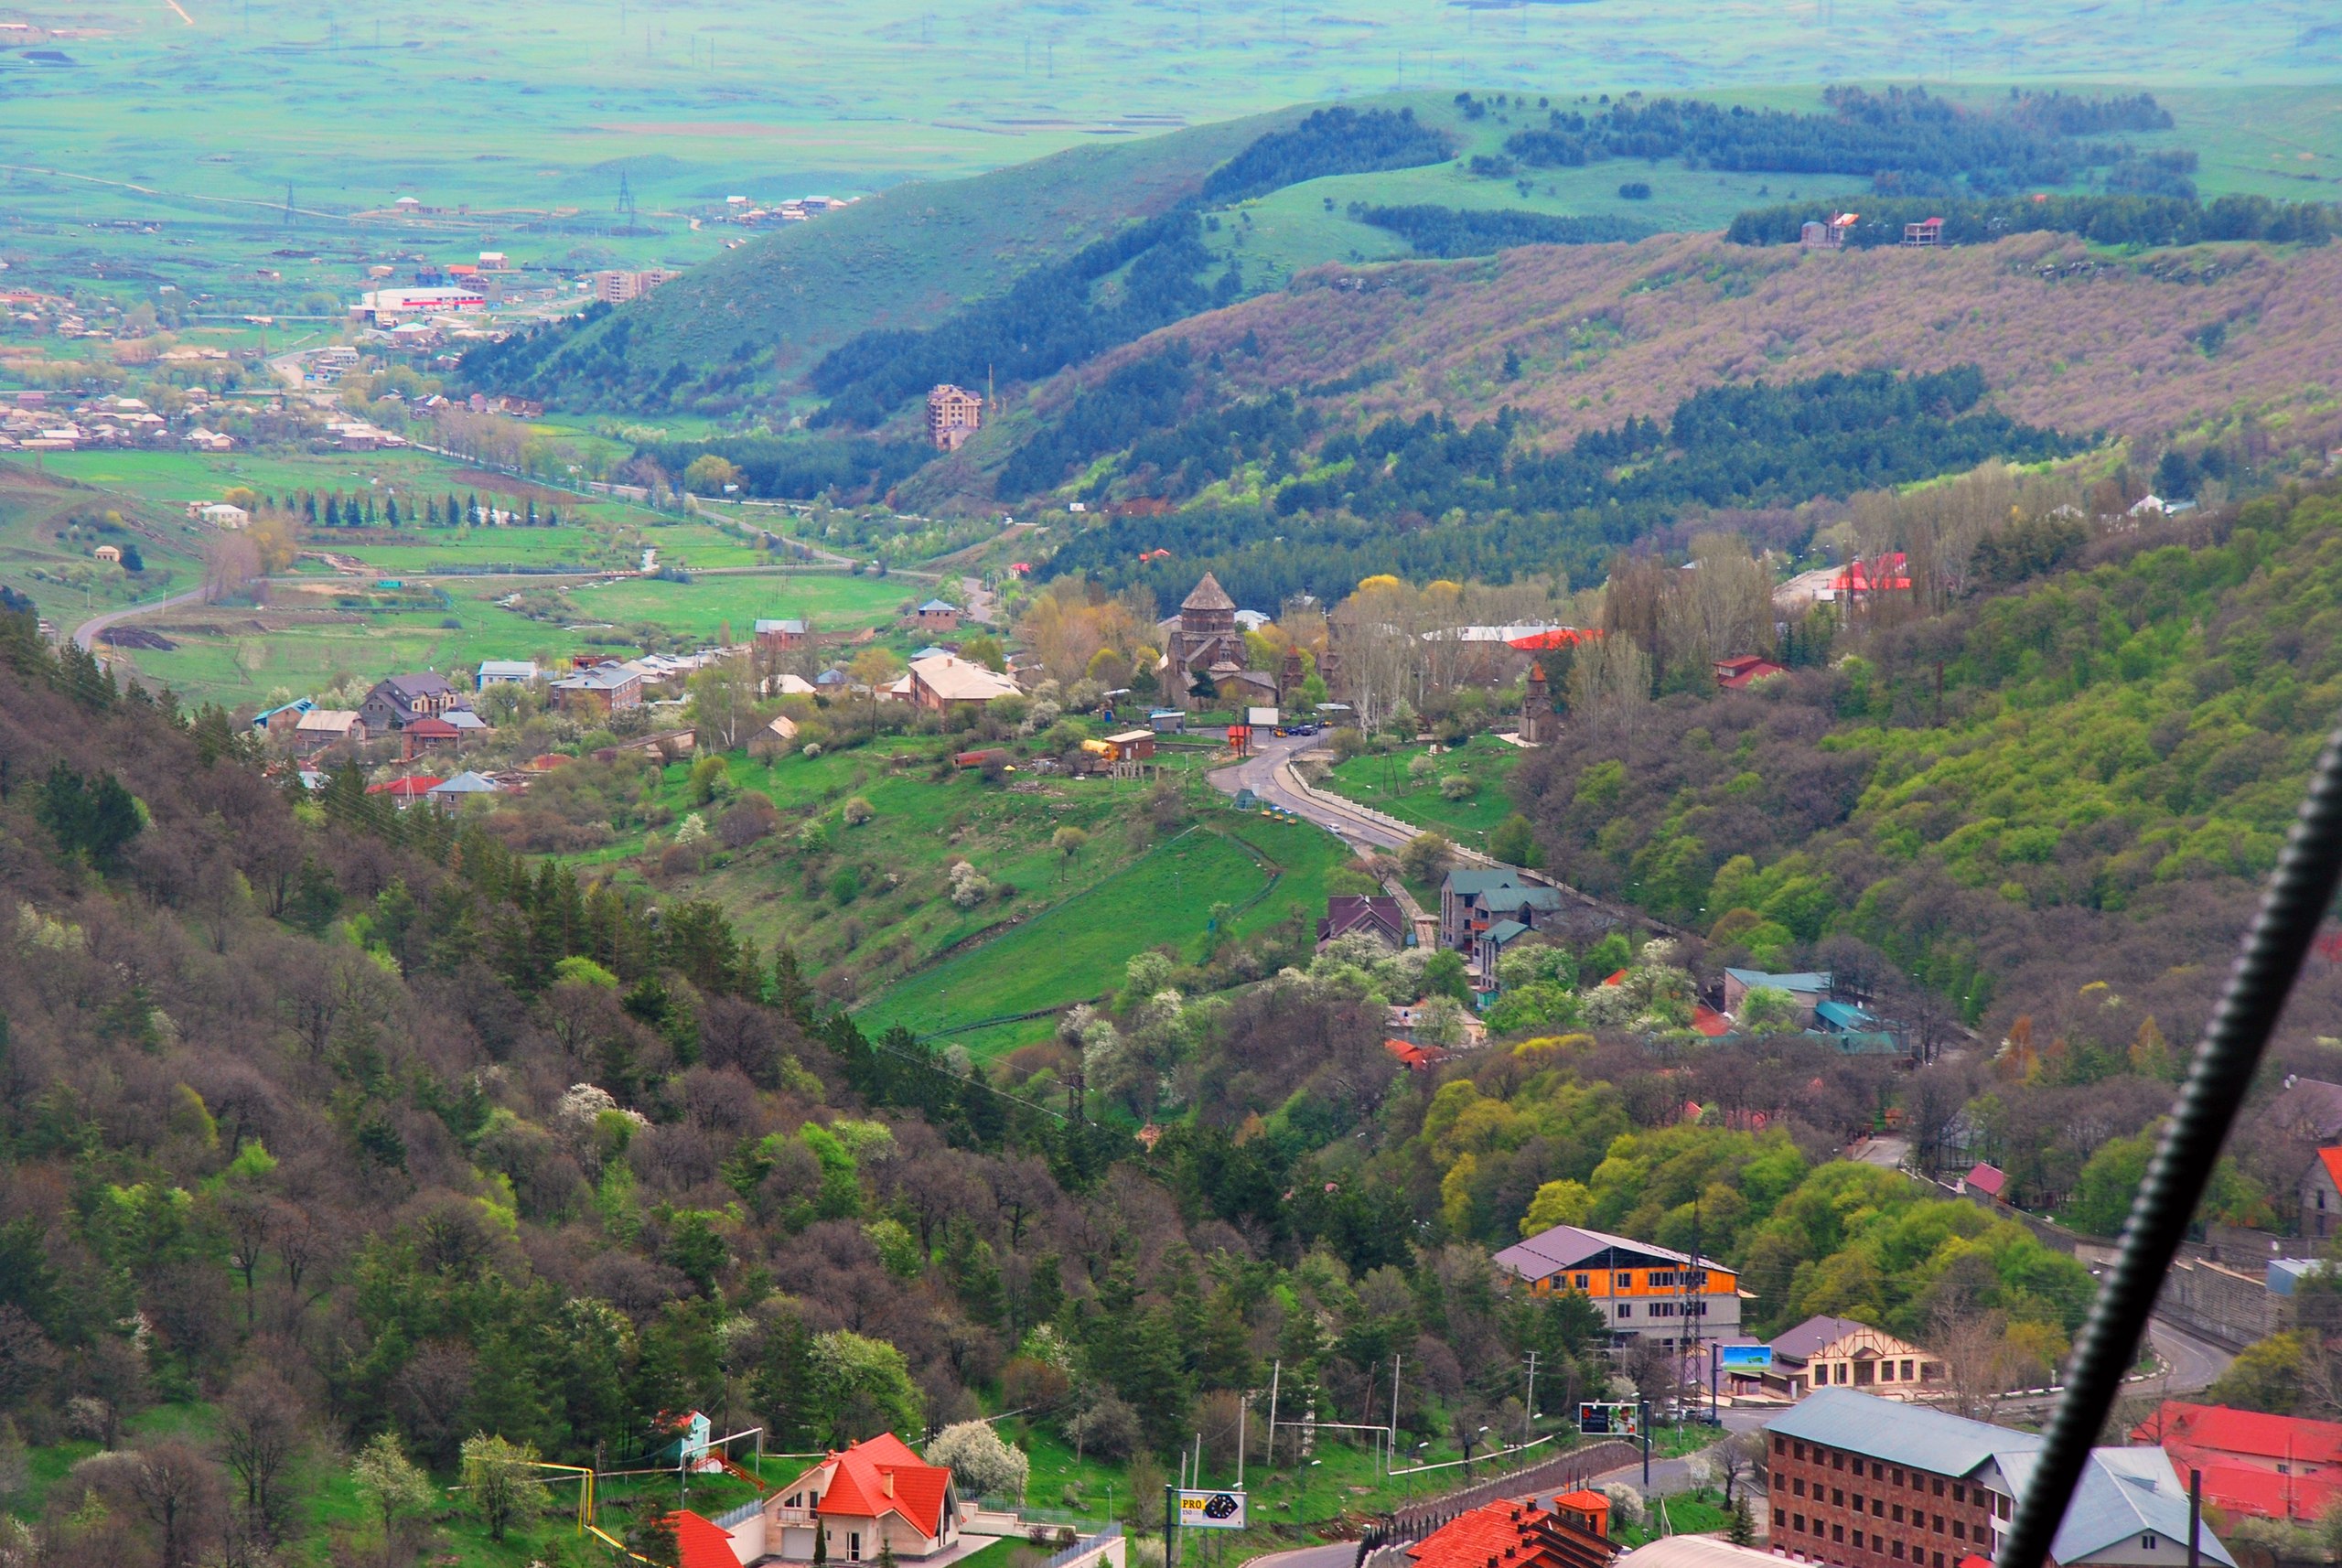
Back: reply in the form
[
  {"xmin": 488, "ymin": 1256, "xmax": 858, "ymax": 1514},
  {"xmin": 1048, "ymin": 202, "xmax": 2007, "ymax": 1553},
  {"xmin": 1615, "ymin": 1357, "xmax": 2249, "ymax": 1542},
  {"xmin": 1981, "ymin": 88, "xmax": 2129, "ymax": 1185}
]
[{"xmin": 1072, "ymin": 234, "xmax": 2342, "ymax": 463}]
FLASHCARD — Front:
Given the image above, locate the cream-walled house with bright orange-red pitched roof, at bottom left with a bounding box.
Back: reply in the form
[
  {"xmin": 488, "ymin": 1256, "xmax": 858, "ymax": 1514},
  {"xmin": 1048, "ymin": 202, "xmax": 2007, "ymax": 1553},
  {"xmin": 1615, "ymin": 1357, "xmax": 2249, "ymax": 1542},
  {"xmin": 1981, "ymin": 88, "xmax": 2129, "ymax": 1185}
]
[{"xmin": 764, "ymin": 1433, "xmax": 961, "ymax": 1563}]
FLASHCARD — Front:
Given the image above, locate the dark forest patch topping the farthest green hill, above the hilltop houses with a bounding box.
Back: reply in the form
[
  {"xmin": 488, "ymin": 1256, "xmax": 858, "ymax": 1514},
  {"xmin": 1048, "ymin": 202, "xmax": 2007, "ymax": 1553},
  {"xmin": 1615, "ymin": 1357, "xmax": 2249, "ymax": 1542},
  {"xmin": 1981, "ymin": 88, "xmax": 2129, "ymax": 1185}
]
[{"xmin": 1504, "ymin": 87, "xmax": 2171, "ymax": 194}]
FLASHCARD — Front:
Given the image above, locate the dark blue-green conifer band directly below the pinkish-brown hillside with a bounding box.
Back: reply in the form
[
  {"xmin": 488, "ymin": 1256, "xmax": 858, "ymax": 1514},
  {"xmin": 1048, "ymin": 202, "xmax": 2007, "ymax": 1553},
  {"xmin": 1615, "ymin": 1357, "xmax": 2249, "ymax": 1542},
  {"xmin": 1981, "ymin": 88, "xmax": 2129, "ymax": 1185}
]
[{"xmin": 1036, "ymin": 370, "xmax": 2079, "ymax": 604}]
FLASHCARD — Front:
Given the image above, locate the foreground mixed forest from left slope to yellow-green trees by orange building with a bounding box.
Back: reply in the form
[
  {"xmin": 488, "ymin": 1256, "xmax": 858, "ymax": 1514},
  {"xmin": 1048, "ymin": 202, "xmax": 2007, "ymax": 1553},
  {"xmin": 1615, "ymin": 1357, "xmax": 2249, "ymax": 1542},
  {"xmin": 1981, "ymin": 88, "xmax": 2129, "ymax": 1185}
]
[{"xmin": 0, "ymin": 613, "xmax": 2126, "ymax": 1568}]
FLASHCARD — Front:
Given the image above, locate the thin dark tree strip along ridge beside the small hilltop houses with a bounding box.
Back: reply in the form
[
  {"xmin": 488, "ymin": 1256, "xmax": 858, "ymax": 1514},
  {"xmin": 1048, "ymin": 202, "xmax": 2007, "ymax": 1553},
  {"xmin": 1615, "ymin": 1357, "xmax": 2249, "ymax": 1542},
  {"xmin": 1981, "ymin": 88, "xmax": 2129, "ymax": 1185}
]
[{"xmin": 1724, "ymin": 194, "xmax": 2335, "ymax": 251}]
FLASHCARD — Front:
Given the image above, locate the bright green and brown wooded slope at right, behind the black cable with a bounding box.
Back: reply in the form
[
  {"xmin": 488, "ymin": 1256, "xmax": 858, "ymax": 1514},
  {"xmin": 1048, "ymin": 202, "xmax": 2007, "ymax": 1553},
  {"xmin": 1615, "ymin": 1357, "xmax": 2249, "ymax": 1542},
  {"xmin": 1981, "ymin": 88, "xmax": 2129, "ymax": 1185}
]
[{"xmin": 1515, "ymin": 487, "xmax": 2342, "ymax": 1058}]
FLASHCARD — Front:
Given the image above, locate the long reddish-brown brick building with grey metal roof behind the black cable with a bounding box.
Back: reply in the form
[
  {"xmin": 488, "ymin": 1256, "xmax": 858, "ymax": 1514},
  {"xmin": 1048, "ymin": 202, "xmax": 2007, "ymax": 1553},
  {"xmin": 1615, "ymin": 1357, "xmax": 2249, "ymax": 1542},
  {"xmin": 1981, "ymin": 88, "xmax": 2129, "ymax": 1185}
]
[{"xmin": 1766, "ymin": 1388, "xmax": 2237, "ymax": 1568}]
